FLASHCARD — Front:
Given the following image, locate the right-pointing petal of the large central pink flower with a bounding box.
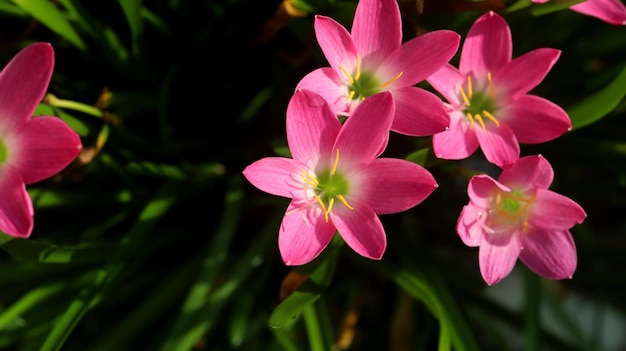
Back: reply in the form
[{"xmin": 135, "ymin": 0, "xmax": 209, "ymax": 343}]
[{"xmin": 358, "ymin": 158, "xmax": 437, "ymax": 214}]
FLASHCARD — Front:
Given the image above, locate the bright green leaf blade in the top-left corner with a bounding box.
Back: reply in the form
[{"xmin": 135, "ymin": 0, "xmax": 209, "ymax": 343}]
[{"xmin": 12, "ymin": 0, "xmax": 86, "ymax": 50}]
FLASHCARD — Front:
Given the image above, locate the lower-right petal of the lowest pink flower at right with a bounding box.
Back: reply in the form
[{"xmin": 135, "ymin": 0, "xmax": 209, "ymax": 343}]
[{"xmin": 519, "ymin": 228, "xmax": 577, "ymax": 279}]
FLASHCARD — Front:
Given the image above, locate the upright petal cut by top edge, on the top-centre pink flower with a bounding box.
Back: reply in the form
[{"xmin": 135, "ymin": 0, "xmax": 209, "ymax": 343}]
[{"xmin": 352, "ymin": 0, "xmax": 402, "ymax": 67}]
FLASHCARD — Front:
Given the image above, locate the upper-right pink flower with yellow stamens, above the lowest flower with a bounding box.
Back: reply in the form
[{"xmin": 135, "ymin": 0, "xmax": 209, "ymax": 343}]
[{"xmin": 427, "ymin": 12, "xmax": 572, "ymax": 167}]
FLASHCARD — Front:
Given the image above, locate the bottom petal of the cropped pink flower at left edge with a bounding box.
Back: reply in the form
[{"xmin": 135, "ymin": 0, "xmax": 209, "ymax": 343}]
[{"xmin": 0, "ymin": 164, "xmax": 33, "ymax": 238}]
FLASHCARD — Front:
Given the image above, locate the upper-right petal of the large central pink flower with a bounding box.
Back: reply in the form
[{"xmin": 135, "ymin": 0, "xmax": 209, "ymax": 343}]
[{"xmin": 335, "ymin": 92, "xmax": 394, "ymax": 169}]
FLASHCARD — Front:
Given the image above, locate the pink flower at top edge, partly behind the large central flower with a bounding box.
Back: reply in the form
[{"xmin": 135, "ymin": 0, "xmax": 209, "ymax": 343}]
[{"xmin": 297, "ymin": 0, "xmax": 460, "ymax": 136}]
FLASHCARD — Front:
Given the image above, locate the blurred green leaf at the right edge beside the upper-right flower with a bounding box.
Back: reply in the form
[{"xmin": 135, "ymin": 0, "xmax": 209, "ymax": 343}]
[{"xmin": 567, "ymin": 62, "xmax": 626, "ymax": 129}]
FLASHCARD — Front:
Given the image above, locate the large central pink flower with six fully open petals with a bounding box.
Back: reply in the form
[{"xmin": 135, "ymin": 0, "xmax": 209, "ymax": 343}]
[{"xmin": 243, "ymin": 90, "xmax": 437, "ymax": 265}]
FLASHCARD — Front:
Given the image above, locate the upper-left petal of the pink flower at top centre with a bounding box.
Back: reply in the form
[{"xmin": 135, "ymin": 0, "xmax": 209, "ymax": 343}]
[{"xmin": 314, "ymin": 15, "xmax": 358, "ymax": 72}]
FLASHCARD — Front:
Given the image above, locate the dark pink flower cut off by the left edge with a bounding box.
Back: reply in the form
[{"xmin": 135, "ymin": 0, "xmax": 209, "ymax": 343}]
[{"xmin": 0, "ymin": 43, "xmax": 82, "ymax": 238}]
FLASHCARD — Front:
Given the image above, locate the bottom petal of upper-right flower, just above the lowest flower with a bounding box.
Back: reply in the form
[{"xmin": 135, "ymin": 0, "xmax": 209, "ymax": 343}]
[{"xmin": 474, "ymin": 124, "xmax": 520, "ymax": 168}]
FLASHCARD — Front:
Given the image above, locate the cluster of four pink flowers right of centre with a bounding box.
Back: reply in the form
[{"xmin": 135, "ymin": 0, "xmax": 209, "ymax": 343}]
[{"xmin": 243, "ymin": 0, "xmax": 607, "ymax": 284}]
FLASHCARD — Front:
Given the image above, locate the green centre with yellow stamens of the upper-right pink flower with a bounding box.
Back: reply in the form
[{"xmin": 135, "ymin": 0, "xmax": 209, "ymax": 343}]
[{"xmin": 459, "ymin": 72, "xmax": 500, "ymax": 130}]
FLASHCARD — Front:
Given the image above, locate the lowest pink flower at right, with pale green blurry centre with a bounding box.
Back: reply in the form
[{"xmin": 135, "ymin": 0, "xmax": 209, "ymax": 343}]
[{"xmin": 456, "ymin": 155, "xmax": 587, "ymax": 285}]
